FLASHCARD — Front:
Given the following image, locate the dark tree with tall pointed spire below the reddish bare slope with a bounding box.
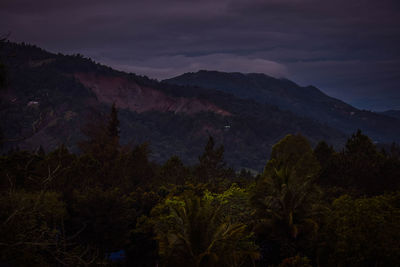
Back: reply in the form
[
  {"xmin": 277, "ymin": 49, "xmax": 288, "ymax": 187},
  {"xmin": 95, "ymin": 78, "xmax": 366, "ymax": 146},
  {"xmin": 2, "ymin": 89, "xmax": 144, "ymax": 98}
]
[{"xmin": 76, "ymin": 104, "xmax": 156, "ymax": 191}]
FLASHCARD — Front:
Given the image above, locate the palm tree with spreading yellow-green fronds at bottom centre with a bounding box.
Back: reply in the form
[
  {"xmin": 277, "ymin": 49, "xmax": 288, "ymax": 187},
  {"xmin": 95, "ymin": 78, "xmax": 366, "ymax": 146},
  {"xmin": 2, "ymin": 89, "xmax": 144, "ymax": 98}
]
[{"xmin": 155, "ymin": 196, "xmax": 259, "ymax": 267}]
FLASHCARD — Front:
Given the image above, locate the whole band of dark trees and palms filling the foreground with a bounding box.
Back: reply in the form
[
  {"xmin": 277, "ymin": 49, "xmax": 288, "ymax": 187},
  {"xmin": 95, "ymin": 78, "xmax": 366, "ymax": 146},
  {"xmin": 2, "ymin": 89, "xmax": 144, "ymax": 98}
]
[{"xmin": 0, "ymin": 103, "xmax": 400, "ymax": 266}]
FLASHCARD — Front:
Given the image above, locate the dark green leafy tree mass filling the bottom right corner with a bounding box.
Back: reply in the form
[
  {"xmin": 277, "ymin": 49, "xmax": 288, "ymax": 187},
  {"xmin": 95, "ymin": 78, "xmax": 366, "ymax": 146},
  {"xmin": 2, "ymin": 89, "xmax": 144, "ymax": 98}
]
[{"xmin": 325, "ymin": 193, "xmax": 400, "ymax": 266}]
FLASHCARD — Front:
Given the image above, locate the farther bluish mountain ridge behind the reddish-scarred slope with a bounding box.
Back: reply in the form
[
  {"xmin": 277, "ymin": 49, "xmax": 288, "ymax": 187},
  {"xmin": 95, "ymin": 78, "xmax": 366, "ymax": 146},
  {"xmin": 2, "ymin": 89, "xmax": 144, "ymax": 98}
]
[{"xmin": 163, "ymin": 70, "xmax": 400, "ymax": 143}]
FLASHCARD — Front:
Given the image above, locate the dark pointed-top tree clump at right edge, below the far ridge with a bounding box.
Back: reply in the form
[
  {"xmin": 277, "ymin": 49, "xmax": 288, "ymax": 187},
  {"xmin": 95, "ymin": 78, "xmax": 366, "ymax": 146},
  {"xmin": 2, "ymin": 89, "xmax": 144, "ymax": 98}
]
[{"xmin": 314, "ymin": 131, "xmax": 400, "ymax": 197}]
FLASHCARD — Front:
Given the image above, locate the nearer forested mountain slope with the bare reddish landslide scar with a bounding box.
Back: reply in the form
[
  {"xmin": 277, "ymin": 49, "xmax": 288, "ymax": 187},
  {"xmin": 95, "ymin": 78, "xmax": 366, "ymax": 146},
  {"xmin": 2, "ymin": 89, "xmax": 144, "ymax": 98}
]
[{"xmin": 0, "ymin": 42, "xmax": 346, "ymax": 170}]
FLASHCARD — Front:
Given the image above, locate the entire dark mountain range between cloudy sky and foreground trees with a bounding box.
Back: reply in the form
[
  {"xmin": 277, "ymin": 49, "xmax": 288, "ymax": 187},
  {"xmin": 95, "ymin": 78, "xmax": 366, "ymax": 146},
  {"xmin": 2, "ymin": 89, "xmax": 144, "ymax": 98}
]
[{"xmin": 0, "ymin": 42, "xmax": 400, "ymax": 170}]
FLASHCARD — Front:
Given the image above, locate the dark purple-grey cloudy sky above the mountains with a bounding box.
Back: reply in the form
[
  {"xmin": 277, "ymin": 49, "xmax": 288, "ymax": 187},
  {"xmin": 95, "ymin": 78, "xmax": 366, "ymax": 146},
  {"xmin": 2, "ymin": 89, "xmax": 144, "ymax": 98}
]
[{"xmin": 0, "ymin": 0, "xmax": 400, "ymax": 110}]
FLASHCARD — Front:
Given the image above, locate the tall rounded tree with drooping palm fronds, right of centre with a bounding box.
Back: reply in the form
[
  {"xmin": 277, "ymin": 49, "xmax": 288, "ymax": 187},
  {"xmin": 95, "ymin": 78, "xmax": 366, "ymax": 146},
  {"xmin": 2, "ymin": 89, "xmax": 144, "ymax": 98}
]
[{"xmin": 252, "ymin": 135, "xmax": 321, "ymax": 256}]
